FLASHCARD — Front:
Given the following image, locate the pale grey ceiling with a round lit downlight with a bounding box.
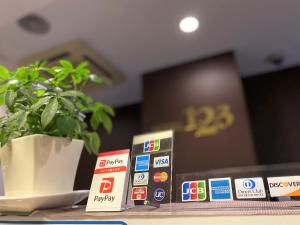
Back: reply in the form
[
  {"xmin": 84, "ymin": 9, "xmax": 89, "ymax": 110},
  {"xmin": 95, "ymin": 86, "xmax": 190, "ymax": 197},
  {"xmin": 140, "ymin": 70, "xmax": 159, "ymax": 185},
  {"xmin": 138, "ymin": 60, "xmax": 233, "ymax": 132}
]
[{"xmin": 0, "ymin": 0, "xmax": 300, "ymax": 106}]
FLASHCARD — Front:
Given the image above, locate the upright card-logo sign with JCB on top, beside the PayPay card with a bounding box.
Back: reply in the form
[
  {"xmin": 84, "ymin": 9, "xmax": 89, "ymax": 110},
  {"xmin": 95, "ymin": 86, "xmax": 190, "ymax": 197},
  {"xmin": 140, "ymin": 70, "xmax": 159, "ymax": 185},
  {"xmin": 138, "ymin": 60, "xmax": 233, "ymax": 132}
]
[{"xmin": 130, "ymin": 130, "xmax": 174, "ymax": 205}]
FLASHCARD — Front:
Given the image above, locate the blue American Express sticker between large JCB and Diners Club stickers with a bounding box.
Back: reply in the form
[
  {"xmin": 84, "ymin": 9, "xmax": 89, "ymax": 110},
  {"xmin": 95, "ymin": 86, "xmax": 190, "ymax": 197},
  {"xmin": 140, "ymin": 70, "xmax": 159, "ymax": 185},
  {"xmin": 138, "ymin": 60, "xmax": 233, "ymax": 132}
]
[{"xmin": 208, "ymin": 177, "xmax": 233, "ymax": 201}]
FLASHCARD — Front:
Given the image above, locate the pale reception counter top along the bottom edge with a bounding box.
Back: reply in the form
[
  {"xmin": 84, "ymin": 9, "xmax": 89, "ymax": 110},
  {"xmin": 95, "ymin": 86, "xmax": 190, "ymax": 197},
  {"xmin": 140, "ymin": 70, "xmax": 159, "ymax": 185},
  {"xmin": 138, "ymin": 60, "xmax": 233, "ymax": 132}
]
[{"xmin": 0, "ymin": 201, "xmax": 300, "ymax": 225}]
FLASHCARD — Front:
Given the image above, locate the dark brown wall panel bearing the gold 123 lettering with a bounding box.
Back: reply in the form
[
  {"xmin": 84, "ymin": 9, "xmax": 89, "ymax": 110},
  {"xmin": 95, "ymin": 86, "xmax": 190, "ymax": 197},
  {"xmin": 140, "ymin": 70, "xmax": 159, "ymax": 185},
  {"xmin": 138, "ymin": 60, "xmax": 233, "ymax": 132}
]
[{"xmin": 142, "ymin": 53, "xmax": 256, "ymax": 173}]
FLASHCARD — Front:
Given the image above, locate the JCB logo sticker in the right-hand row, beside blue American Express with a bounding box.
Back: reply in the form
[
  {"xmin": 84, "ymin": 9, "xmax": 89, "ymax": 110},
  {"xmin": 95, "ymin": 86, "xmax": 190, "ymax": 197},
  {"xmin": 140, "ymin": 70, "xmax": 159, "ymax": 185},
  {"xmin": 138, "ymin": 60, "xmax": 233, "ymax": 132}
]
[{"xmin": 181, "ymin": 180, "xmax": 206, "ymax": 202}]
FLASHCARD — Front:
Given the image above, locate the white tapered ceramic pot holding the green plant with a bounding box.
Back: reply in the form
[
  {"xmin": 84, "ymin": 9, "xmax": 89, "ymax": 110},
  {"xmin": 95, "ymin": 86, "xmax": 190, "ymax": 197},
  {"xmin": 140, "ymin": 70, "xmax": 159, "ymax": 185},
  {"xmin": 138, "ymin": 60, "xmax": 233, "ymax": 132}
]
[{"xmin": 0, "ymin": 135, "xmax": 83, "ymax": 197}]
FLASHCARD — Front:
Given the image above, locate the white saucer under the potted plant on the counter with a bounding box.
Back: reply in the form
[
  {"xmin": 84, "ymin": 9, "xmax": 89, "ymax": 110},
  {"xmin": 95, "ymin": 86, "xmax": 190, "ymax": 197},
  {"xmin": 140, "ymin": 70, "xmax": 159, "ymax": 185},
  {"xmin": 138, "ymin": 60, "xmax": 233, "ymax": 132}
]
[{"xmin": 0, "ymin": 190, "xmax": 89, "ymax": 213}]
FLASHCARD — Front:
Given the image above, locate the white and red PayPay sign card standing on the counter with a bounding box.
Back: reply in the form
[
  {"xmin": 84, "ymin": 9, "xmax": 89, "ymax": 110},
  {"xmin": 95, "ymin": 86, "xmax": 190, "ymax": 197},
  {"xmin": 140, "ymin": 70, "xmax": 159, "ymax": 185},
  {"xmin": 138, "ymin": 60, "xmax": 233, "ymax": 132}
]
[{"xmin": 86, "ymin": 149, "xmax": 130, "ymax": 212}]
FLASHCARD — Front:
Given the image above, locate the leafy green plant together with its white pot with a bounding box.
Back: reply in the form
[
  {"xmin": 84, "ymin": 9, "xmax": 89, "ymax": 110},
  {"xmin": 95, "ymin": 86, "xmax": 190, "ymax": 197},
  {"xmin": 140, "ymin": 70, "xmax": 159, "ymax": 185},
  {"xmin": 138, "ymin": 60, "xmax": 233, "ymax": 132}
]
[{"xmin": 0, "ymin": 60, "xmax": 114, "ymax": 197}]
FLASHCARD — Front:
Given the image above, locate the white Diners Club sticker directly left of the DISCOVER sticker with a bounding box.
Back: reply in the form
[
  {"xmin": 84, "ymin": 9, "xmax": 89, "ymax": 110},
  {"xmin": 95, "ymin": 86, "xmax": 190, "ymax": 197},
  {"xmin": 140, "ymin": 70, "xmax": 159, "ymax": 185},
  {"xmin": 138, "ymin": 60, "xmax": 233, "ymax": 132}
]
[{"xmin": 234, "ymin": 177, "xmax": 266, "ymax": 199}]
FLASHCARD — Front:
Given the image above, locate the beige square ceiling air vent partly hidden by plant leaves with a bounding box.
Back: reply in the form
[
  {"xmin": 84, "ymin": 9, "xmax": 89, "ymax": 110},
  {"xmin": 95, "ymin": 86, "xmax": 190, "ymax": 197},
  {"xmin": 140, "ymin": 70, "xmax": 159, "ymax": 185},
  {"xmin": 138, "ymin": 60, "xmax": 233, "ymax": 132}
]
[{"xmin": 19, "ymin": 41, "xmax": 124, "ymax": 92}]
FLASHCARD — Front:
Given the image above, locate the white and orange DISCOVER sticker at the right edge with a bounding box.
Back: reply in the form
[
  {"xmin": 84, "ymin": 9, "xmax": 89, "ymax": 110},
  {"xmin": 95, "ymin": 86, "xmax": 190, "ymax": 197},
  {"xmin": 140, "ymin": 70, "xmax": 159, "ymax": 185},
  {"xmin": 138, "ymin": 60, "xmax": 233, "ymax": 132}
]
[{"xmin": 267, "ymin": 176, "xmax": 300, "ymax": 197}]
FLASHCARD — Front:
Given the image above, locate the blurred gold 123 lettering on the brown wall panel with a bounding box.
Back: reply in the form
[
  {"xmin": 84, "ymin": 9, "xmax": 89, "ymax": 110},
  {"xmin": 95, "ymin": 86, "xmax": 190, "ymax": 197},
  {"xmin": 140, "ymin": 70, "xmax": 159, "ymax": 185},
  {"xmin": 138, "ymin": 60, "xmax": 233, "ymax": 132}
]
[{"xmin": 153, "ymin": 104, "xmax": 235, "ymax": 138}]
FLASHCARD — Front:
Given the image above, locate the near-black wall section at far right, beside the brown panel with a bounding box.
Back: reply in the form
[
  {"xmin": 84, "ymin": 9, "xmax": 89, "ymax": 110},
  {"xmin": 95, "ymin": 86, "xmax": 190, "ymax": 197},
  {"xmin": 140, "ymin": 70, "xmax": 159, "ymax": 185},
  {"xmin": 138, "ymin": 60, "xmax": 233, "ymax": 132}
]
[{"xmin": 243, "ymin": 67, "xmax": 300, "ymax": 164}]
